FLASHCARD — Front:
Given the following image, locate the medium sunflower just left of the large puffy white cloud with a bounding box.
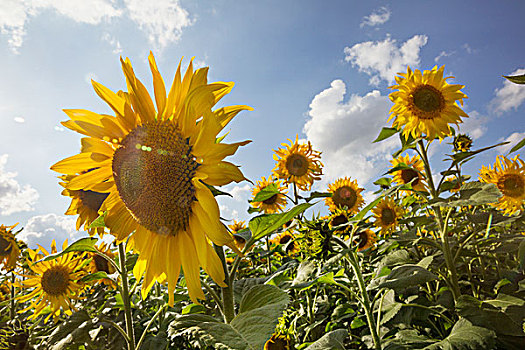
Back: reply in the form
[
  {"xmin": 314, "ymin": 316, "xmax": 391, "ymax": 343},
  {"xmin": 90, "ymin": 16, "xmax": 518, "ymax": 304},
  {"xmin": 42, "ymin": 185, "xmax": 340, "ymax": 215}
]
[{"xmin": 273, "ymin": 135, "xmax": 323, "ymax": 191}]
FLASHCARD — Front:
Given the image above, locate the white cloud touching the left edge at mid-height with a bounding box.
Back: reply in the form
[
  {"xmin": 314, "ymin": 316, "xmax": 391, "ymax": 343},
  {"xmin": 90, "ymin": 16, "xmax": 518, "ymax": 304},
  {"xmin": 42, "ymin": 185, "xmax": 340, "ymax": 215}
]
[{"xmin": 0, "ymin": 154, "xmax": 39, "ymax": 215}]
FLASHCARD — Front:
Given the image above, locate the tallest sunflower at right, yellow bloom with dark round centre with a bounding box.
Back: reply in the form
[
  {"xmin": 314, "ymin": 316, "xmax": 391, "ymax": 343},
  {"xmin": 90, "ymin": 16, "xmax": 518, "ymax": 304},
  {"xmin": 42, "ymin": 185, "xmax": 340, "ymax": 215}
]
[{"xmin": 388, "ymin": 66, "xmax": 468, "ymax": 140}]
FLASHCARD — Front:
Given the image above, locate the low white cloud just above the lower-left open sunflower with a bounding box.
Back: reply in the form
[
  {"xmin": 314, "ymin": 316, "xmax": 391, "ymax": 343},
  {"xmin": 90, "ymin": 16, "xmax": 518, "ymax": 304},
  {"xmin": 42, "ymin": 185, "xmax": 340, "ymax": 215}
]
[{"xmin": 17, "ymin": 213, "xmax": 87, "ymax": 251}]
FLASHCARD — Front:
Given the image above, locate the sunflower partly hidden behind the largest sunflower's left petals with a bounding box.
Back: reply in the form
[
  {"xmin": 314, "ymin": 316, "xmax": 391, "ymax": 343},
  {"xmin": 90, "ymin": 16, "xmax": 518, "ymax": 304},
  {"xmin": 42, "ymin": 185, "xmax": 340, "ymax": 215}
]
[{"xmin": 60, "ymin": 175, "xmax": 109, "ymax": 237}]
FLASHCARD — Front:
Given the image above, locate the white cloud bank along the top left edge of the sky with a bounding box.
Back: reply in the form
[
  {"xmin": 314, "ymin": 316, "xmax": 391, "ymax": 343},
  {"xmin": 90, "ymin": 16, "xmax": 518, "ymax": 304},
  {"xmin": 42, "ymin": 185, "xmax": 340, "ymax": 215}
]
[{"xmin": 0, "ymin": 0, "xmax": 193, "ymax": 53}]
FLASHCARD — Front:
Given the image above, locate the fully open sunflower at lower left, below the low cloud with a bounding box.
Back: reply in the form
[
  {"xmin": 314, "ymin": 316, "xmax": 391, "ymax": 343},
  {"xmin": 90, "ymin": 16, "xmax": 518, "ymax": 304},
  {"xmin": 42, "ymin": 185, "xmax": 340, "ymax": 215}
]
[{"xmin": 16, "ymin": 240, "xmax": 86, "ymax": 322}]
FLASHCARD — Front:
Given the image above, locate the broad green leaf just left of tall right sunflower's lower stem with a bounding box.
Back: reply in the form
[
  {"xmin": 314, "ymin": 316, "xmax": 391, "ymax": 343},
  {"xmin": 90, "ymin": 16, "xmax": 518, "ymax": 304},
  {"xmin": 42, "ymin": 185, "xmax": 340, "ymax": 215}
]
[{"xmin": 378, "ymin": 264, "xmax": 437, "ymax": 290}]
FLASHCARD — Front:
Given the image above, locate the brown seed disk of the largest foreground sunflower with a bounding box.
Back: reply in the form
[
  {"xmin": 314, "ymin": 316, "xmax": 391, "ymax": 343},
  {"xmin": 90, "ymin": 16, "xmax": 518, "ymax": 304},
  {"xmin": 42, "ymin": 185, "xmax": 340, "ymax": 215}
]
[{"xmin": 113, "ymin": 121, "xmax": 199, "ymax": 235}]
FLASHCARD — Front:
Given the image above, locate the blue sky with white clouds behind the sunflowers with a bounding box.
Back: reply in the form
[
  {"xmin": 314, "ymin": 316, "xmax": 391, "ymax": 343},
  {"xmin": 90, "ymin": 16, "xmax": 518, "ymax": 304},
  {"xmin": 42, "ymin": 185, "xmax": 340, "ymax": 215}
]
[{"xmin": 0, "ymin": 0, "xmax": 525, "ymax": 252}]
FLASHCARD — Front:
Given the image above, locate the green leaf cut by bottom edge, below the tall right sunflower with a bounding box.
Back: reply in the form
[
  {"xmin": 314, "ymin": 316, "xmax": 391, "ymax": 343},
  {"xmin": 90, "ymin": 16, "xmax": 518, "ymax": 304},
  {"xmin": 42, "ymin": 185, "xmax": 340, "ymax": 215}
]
[{"xmin": 424, "ymin": 318, "xmax": 496, "ymax": 350}]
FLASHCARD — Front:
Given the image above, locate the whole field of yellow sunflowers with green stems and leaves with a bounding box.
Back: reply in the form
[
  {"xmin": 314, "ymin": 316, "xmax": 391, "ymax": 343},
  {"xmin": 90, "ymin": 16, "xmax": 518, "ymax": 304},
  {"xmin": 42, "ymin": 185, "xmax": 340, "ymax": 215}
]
[{"xmin": 0, "ymin": 55, "xmax": 525, "ymax": 350}]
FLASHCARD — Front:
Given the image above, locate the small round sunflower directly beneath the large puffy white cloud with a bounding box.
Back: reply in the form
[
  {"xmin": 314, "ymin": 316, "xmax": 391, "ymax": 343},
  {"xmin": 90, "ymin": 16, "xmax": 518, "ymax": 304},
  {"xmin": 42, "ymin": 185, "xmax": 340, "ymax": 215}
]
[{"xmin": 325, "ymin": 177, "xmax": 364, "ymax": 214}]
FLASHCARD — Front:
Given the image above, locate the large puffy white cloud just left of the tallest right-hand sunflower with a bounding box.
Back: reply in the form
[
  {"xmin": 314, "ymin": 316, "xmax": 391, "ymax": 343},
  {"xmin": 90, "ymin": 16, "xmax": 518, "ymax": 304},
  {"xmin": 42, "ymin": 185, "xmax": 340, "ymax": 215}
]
[{"xmin": 303, "ymin": 80, "xmax": 399, "ymax": 186}]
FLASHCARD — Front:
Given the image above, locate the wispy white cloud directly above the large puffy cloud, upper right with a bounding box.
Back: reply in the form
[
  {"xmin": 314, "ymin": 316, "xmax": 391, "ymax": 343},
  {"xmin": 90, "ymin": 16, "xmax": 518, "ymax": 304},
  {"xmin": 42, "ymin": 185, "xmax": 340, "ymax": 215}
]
[{"xmin": 344, "ymin": 35, "xmax": 428, "ymax": 85}]
